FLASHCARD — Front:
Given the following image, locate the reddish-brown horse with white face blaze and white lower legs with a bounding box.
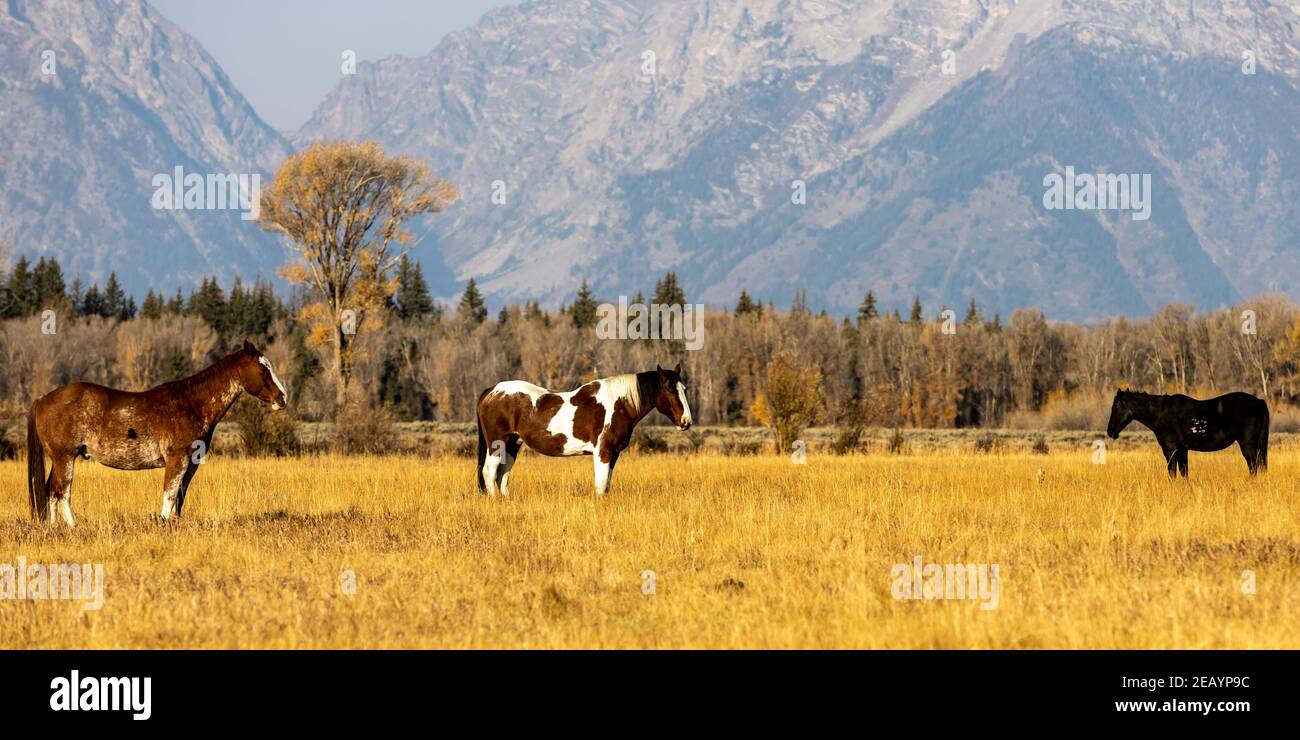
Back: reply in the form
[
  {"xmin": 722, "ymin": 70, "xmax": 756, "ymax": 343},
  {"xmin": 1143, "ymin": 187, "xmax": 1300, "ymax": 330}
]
[{"xmin": 27, "ymin": 339, "xmax": 287, "ymax": 527}]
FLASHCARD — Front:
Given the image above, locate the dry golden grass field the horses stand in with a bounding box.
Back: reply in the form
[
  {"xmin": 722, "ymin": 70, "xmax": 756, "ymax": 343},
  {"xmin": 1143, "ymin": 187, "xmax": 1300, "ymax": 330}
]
[{"xmin": 0, "ymin": 443, "xmax": 1300, "ymax": 648}]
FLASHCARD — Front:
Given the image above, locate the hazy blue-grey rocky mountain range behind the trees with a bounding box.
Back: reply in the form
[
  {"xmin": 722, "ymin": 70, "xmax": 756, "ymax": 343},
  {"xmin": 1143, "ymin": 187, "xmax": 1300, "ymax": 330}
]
[{"xmin": 0, "ymin": 0, "xmax": 1300, "ymax": 319}]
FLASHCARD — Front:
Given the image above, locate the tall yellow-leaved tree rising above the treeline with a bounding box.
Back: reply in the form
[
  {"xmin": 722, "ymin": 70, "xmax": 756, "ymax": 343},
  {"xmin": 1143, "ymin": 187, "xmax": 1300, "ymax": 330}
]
[{"xmin": 259, "ymin": 140, "xmax": 459, "ymax": 408}]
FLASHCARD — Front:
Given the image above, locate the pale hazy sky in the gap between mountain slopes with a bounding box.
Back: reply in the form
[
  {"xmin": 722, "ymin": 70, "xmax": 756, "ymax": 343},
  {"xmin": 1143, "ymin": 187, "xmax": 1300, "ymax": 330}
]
[{"xmin": 150, "ymin": 0, "xmax": 517, "ymax": 131}]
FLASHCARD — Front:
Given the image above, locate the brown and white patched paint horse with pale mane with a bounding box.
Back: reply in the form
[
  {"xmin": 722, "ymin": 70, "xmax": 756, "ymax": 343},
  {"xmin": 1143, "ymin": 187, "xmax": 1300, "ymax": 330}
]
[{"xmin": 478, "ymin": 364, "xmax": 690, "ymax": 496}]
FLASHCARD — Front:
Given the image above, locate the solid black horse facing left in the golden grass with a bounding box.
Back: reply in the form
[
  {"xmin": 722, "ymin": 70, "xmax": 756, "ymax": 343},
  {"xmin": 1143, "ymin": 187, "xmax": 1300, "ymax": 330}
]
[{"xmin": 1106, "ymin": 390, "xmax": 1269, "ymax": 477}]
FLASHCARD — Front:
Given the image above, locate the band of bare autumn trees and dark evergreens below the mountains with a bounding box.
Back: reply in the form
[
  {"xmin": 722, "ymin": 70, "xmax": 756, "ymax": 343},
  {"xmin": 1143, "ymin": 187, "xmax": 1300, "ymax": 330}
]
[{"xmin": 0, "ymin": 258, "xmax": 1300, "ymax": 434}]
